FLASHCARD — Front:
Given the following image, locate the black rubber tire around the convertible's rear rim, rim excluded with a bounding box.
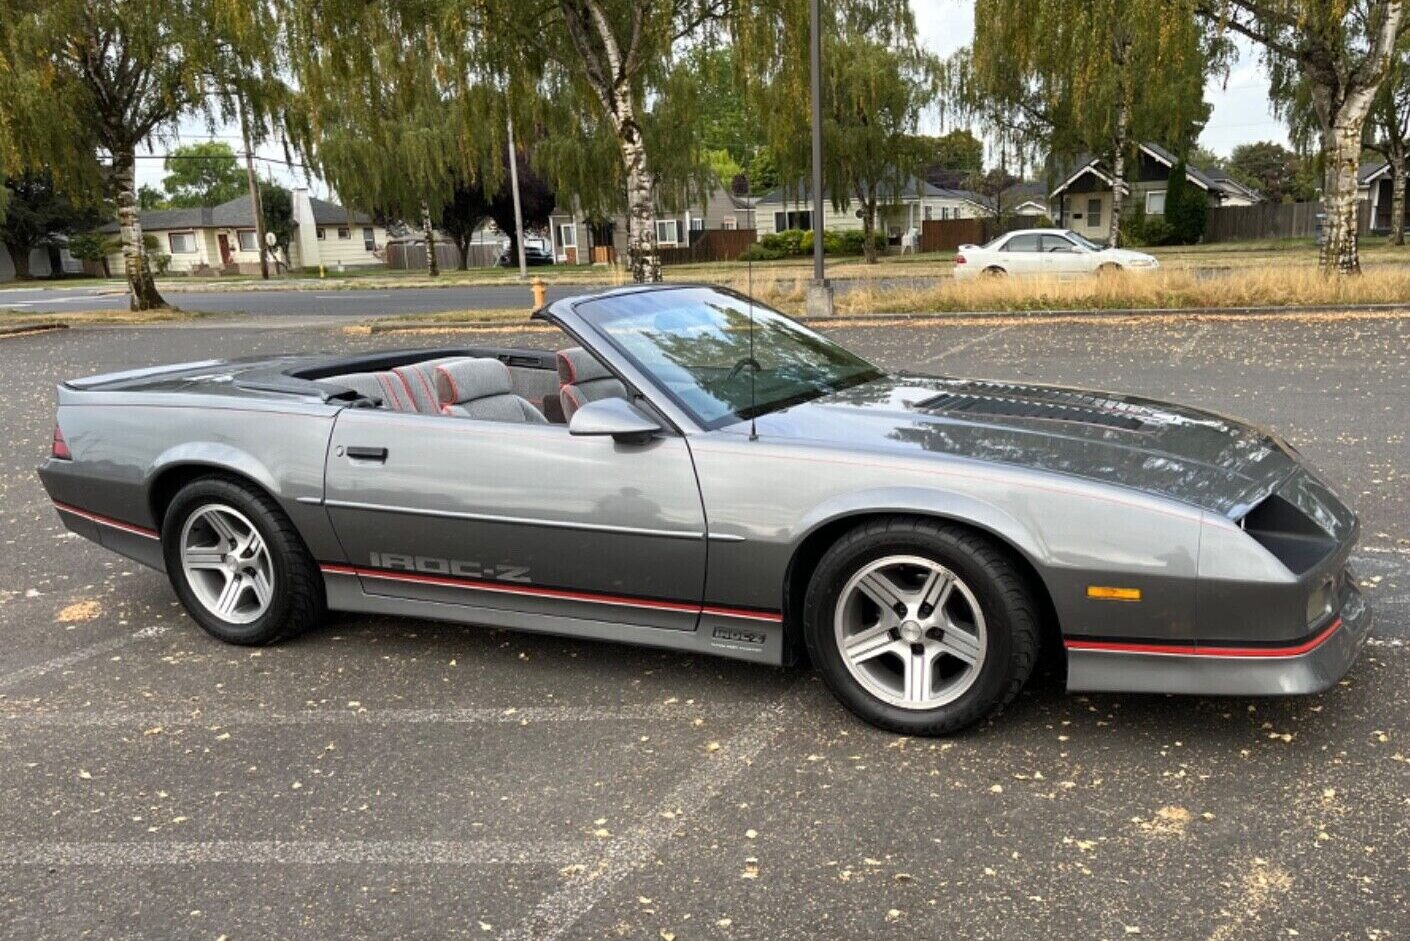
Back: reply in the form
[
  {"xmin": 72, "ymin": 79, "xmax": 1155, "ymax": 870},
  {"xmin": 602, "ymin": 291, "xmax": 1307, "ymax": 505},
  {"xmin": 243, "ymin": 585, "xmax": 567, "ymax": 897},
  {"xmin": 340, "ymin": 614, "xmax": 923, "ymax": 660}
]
[{"xmin": 162, "ymin": 475, "xmax": 327, "ymax": 646}]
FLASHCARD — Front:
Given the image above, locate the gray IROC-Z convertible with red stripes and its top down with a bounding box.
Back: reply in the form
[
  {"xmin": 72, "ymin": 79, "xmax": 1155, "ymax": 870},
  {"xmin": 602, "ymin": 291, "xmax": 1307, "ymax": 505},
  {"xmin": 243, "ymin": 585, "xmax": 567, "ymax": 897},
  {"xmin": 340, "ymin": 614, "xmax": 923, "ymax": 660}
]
[{"xmin": 39, "ymin": 286, "xmax": 1371, "ymax": 735}]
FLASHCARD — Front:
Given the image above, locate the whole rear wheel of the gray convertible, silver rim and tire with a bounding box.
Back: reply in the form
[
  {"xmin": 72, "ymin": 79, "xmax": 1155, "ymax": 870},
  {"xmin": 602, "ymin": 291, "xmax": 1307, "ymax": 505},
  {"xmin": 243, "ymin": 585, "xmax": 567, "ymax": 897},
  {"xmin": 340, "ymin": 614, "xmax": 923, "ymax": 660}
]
[{"xmin": 162, "ymin": 477, "xmax": 327, "ymax": 645}]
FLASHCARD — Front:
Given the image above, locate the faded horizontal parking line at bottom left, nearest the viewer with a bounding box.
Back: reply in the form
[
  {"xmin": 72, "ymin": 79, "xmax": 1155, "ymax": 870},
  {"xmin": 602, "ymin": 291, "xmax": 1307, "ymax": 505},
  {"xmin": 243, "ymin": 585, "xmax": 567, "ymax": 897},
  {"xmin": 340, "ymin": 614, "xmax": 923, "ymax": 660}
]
[{"xmin": 0, "ymin": 839, "xmax": 591, "ymax": 866}]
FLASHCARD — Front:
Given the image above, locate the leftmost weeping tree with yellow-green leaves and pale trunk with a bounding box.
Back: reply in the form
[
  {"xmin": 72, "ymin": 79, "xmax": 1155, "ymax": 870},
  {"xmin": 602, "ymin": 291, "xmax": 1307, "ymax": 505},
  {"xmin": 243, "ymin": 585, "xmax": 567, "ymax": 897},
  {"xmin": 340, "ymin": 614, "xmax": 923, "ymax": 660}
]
[{"xmin": 0, "ymin": 0, "xmax": 277, "ymax": 310}]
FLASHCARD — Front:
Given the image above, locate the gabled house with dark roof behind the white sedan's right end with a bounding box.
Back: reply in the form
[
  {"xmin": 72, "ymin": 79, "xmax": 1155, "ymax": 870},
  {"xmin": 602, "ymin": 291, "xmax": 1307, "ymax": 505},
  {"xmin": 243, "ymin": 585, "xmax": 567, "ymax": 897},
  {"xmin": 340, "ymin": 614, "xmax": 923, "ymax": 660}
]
[{"xmin": 1048, "ymin": 142, "xmax": 1263, "ymax": 238}]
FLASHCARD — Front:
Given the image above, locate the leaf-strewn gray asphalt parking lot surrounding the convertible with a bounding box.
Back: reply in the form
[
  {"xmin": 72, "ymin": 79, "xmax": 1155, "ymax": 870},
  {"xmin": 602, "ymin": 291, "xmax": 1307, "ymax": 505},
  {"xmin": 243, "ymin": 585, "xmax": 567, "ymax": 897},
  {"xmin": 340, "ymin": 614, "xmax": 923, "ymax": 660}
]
[{"xmin": 0, "ymin": 316, "xmax": 1410, "ymax": 941}]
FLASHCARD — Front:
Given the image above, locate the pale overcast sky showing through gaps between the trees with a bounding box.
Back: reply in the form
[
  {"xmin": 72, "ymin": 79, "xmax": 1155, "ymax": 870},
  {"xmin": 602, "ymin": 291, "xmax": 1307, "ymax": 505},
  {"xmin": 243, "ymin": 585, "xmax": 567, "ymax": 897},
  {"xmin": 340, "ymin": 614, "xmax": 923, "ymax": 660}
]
[{"xmin": 137, "ymin": 0, "xmax": 1287, "ymax": 198}]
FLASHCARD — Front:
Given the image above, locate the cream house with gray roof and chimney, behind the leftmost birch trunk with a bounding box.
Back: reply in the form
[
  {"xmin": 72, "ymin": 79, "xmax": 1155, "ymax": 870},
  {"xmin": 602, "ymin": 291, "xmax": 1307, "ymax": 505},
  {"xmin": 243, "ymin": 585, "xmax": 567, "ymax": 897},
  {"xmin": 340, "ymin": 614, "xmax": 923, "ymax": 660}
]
[{"xmin": 99, "ymin": 189, "xmax": 386, "ymax": 274}]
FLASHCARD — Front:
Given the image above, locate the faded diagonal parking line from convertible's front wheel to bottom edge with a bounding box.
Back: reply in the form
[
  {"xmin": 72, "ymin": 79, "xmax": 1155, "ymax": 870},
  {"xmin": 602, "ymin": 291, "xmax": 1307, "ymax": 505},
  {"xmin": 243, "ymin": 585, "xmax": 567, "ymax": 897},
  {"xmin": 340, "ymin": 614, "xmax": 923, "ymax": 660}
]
[{"xmin": 503, "ymin": 683, "xmax": 805, "ymax": 941}]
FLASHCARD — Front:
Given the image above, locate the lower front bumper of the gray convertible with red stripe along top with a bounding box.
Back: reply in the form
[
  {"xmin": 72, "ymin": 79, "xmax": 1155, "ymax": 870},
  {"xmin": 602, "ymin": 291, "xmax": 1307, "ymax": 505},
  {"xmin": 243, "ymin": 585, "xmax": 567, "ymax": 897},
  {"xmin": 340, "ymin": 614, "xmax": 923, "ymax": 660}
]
[{"xmin": 1066, "ymin": 583, "xmax": 1372, "ymax": 696}]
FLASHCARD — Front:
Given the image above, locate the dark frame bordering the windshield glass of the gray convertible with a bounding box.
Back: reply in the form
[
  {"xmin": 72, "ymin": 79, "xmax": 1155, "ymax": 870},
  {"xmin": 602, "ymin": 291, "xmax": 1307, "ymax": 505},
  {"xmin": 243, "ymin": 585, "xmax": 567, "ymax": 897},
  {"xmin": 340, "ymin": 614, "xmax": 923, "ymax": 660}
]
[{"xmin": 570, "ymin": 284, "xmax": 885, "ymax": 432}]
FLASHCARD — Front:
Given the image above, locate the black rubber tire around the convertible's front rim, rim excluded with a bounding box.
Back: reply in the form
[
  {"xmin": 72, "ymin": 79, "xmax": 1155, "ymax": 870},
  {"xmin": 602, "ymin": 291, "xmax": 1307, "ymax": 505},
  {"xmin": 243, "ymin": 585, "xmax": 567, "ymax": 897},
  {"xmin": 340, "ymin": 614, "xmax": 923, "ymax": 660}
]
[{"xmin": 802, "ymin": 516, "xmax": 1039, "ymax": 735}]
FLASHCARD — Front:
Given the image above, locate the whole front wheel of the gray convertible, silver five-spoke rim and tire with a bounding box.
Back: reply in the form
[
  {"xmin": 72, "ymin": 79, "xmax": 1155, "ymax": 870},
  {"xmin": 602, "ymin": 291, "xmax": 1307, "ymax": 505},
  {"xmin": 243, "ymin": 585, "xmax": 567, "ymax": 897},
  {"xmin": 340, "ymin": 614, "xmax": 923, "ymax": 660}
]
[{"xmin": 804, "ymin": 516, "xmax": 1039, "ymax": 735}]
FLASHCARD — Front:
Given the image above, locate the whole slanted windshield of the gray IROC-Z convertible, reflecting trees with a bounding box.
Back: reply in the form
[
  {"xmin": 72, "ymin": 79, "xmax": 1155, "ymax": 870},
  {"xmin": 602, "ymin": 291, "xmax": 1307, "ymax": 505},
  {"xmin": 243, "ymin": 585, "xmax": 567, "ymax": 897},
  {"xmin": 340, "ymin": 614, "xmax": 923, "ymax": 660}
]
[{"xmin": 577, "ymin": 288, "xmax": 881, "ymax": 429}]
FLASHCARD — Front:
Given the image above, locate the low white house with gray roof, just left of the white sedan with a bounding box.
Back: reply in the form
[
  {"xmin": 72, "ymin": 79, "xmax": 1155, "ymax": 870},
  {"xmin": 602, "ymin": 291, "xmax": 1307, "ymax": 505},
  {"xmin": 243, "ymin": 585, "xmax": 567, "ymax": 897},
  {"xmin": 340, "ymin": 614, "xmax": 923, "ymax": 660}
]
[{"xmin": 756, "ymin": 176, "xmax": 994, "ymax": 238}]
